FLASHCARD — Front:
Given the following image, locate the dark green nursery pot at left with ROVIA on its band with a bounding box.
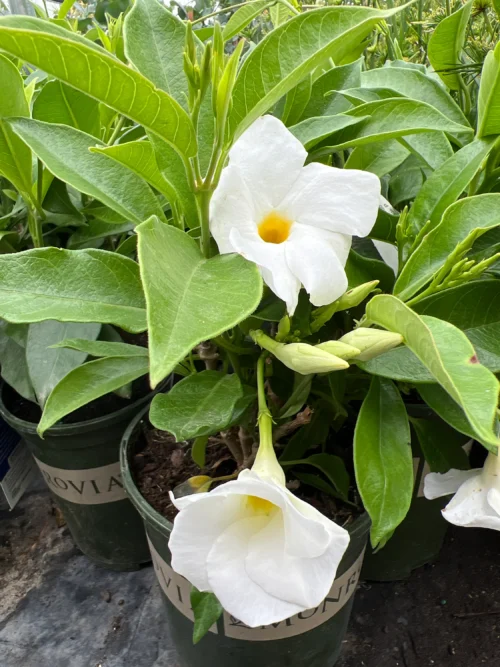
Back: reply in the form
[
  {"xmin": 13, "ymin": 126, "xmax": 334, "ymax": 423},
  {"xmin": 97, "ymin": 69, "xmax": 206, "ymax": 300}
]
[{"xmin": 0, "ymin": 384, "xmax": 160, "ymax": 570}]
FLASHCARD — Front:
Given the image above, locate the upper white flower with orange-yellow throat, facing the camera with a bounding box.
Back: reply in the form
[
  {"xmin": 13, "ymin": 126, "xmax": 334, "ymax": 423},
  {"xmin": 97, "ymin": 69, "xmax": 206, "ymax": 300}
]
[{"xmin": 210, "ymin": 116, "xmax": 380, "ymax": 314}]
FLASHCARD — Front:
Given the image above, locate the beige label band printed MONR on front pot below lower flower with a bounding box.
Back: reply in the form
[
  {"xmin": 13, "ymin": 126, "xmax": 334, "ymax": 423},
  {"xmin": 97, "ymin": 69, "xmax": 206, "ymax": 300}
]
[{"xmin": 224, "ymin": 551, "xmax": 364, "ymax": 642}]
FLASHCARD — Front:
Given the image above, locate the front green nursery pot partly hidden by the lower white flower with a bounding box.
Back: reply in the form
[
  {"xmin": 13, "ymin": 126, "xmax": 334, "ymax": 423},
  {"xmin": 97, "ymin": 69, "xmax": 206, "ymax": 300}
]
[{"xmin": 120, "ymin": 410, "xmax": 370, "ymax": 667}]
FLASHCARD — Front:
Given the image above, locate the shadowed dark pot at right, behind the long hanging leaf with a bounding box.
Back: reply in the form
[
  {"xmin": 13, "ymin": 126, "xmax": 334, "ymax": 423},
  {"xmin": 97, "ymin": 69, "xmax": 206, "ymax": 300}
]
[{"xmin": 362, "ymin": 406, "xmax": 449, "ymax": 581}]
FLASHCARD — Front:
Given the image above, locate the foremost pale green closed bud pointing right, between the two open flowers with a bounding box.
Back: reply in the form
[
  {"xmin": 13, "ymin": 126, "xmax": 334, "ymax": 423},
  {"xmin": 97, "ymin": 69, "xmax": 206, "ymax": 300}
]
[{"xmin": 250, "ymin": 331, "xmax": 349, "ymax": 375}]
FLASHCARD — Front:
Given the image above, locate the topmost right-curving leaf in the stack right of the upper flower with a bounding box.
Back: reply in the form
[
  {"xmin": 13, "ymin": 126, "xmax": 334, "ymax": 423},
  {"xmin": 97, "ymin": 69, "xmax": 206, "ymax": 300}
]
[{"xmin": 361, "ymin": 67, "xmax": 470, "ymax": 132}]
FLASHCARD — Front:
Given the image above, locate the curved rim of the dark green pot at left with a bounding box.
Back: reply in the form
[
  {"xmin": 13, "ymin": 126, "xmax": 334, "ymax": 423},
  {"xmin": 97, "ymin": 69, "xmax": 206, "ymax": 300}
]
[{"xmin": 0, "ymin": 376, "xmax": 173, "ymax": 437}]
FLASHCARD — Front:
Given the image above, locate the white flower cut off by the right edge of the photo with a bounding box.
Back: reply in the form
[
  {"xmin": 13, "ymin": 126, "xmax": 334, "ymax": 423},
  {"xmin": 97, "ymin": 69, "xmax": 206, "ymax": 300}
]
[{"xmin": 424, "ymin": 453, "xmax": 500, "ymax": 530}]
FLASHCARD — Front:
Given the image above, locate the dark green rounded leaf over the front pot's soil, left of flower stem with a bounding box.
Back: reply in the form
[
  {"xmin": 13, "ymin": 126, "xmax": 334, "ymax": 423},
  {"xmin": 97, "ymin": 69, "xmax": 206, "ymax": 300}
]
[{"xmin": 149, "ymin": 371, "xmax": 243, "ymax": 442}]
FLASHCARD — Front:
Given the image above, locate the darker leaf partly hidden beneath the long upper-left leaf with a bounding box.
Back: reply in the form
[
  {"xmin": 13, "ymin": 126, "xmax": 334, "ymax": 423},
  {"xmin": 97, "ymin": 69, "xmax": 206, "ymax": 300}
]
[{"xmin": 32, "ymin": 81, "xmax": 101, "ymax": 138}]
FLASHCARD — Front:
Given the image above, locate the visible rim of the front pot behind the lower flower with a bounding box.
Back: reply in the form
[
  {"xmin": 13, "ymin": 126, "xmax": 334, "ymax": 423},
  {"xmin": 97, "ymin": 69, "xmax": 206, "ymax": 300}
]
[{"xmin": 120, "ymin": 405, "xmax": 371, "ymax": 537}]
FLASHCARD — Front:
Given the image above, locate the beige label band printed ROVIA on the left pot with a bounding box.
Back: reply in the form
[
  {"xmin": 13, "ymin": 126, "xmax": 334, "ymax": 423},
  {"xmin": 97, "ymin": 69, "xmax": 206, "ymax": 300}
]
[{"xmin": 35, "ymin": 458, "xmax": 127, "ymax": 505}]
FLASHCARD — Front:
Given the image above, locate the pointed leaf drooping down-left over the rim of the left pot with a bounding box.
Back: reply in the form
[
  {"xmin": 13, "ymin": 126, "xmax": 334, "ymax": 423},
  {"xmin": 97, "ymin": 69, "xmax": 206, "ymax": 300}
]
[{"xmin": 37, "ymin": 357, "xmax": 148, "ymax": 437}]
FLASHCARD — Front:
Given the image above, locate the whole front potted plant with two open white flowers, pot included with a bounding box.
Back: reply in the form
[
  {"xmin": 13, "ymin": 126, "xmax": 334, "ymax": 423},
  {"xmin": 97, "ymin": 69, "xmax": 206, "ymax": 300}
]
[{"xmin": 0, "ymin": 0, "xmax": 499, "ymax": 667}]
